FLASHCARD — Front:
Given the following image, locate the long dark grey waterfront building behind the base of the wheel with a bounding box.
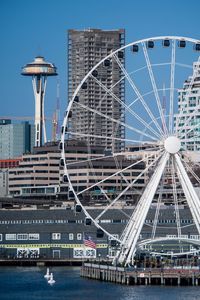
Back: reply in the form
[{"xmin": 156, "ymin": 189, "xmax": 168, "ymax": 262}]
[{"xmin": 0, "ymin": 207, "xmax": 197, "ymax": 261}]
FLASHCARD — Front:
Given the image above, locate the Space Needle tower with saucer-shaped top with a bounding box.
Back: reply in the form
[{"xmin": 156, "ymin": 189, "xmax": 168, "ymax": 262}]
[{"xmin": 21, "ymin": 56, "xmax": 57, "ymax": 147}]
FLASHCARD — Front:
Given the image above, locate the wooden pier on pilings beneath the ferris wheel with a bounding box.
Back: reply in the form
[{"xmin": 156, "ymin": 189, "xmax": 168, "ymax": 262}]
[{"xmin": 81, "ymin": 263, "xmax": 200, "ymax": 286}]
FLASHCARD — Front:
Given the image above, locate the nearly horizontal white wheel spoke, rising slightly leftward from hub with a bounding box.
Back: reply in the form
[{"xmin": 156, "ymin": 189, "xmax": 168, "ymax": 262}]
[{"xmin": 66, "ymin": 131, "xmax": 155, "ymax": 145}]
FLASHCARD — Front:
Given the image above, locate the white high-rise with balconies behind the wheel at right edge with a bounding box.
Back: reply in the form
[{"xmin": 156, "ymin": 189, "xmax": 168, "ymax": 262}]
[{"xmin": 175, "ymin": 62, "xmax": 200, "ymax": 151}]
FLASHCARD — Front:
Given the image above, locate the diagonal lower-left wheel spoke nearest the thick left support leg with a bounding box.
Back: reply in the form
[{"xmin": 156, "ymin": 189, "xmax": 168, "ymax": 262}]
[{"xmin": 95, "ymin": 151, "xmax": 163, "ymax": 221}]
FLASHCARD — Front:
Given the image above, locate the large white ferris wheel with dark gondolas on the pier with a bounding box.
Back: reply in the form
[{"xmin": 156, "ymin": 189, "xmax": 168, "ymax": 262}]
[{"xmin": 60, "ymin": 36, "xmax": 200, "ymax": 263}]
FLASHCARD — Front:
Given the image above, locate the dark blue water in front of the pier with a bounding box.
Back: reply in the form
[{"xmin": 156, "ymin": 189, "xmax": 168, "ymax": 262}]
[{"xmin": 0, "ymin": 267, "xmax": 200, "ymax": 300}]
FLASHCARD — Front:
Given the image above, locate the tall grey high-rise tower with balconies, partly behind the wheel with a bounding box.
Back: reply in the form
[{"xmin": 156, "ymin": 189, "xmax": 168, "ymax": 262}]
[{"xmin": 68, "ymin": 29, "xmax": 125, "ymax": 152}]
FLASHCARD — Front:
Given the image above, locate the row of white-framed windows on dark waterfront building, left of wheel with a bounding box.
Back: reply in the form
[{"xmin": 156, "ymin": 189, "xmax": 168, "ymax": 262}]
[{"xmin": 0, "ymin": 232, "xmax": 83, "ymax": 241}]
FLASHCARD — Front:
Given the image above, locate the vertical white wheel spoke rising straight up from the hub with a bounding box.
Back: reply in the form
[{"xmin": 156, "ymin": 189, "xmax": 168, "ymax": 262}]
[{"xmin": 169, "ymin": 40, "xmax": 176, "ymax": 134}]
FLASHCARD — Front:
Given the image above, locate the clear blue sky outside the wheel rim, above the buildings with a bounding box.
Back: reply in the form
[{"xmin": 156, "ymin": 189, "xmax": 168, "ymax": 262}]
[{"xmin": 0, "ymin": 0, "xmax": 200, "ymax": 139}]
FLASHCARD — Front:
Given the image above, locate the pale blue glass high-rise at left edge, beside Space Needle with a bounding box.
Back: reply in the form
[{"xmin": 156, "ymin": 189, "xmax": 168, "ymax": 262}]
[{"xmin": 0, "ymin": 119, "xmax": 34, "ymax": 159}]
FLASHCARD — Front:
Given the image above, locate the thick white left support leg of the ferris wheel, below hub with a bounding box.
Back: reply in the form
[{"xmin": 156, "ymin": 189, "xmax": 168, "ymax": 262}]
[{"xmin": 114, "ymin": 152, "xmax": 169, "ymax": 265}]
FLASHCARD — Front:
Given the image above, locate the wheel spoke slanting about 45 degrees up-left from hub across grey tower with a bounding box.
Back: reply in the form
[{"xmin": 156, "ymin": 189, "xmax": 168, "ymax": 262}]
[{"xmin": 91, "ymin": 75, "xmax": 160, "ymax": 141}]
